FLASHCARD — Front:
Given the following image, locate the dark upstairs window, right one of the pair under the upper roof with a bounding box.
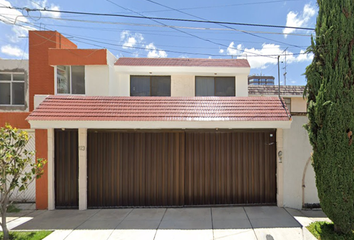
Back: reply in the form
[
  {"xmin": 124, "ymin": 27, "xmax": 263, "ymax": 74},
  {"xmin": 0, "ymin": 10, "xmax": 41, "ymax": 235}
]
[{"xmin": 195, "ymin": 77, "xmax": 235, "ymax": 96}]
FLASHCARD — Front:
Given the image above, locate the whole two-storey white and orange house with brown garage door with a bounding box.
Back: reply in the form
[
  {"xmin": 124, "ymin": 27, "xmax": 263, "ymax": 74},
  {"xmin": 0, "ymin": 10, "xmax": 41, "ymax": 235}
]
[{"xmin": 0, "ymin": 31, "xmax": 318, "ymax": 209}]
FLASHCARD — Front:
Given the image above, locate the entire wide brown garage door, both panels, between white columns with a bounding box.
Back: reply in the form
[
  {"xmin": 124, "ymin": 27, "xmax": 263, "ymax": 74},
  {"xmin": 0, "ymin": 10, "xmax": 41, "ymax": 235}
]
[{"xmin": 87, "ymin": 130, "xmax": 276, "ymax": 208}]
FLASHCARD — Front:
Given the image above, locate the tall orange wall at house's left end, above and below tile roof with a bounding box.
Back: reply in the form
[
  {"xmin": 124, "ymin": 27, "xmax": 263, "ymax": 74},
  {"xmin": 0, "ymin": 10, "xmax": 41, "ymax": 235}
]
[{"xmin": 29, "ymin": 31, "xmax": 77, "ymax": 209}]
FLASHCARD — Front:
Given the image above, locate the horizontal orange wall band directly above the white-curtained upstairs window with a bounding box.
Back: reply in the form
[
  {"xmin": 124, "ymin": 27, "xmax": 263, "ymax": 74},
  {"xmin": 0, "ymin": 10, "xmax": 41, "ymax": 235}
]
[{"xmin": 49, "ymin": 49, "xmax": 107, "ymax": 65}]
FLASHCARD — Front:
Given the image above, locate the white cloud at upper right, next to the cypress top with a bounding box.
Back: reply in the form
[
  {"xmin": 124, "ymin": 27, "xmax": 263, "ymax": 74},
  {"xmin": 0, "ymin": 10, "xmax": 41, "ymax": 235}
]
[{"xmin": 283, "ymin": 4, "xmax": 316, "ymax": 38}]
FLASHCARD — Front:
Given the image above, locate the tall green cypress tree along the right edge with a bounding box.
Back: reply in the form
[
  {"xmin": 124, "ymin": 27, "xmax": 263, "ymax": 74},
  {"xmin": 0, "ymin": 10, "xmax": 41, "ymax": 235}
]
[{"xmin": 305, "ymin": 0, "xmax": 354, "ymax": 233}]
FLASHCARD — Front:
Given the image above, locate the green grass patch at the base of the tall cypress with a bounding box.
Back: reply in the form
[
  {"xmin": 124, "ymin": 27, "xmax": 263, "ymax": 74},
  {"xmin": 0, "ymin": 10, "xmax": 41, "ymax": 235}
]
[{"xmin": 306, "ymin": 222, "xmax": 354, "ymax": 240}]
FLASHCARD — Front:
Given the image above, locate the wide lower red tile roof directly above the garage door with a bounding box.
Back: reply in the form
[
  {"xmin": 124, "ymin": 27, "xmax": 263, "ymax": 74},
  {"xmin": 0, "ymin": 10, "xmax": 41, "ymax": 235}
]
[{"xmin": 26, "ymin": 96, "xmax": 289, "ymax": 121}]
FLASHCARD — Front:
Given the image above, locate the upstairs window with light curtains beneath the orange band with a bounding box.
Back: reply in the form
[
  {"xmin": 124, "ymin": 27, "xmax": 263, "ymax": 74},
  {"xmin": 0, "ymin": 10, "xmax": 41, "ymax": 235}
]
[{"xmin": 57, "ymin": 66, "xmax": 85, "ymax": 94}]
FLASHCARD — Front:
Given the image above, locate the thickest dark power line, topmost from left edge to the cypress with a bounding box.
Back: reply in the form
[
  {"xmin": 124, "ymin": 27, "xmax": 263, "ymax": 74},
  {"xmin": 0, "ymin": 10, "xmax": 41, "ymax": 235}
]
[{"xmin": 0, "ymin": 6, "xmax": 315, "ymax": 31}]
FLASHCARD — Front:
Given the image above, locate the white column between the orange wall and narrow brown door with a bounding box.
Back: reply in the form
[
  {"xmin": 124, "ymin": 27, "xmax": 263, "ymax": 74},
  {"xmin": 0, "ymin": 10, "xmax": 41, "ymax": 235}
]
[{"xmin": 47, "ymin": 128, "xmax": 55, "ymax": 210}]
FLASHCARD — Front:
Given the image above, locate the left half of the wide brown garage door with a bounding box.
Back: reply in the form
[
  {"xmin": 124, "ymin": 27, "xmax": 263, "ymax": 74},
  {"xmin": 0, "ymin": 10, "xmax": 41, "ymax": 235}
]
[{"xmin": 88, "ymin": 131, "xmax": 184, "ymax": 207}]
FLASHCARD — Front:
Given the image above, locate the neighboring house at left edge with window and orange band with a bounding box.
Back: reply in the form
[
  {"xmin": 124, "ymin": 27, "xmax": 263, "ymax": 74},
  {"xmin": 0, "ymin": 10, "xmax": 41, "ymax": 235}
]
[{"xmin": 0, "ymin": 58, "xmax": 36, "ymax": 202}]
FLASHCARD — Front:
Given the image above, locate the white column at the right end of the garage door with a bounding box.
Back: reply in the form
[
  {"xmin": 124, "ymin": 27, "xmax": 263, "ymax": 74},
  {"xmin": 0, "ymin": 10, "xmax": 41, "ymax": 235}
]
[{"xmin": 276, "ymin": 128, "xmax": 284, "ymax": 207}]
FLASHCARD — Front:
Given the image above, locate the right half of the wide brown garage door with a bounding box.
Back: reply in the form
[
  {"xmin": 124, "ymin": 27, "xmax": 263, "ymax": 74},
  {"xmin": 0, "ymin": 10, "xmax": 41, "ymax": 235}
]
[{"xmin": 185, "ymin": 131, "xmax": 276, "ymax": 205}]
